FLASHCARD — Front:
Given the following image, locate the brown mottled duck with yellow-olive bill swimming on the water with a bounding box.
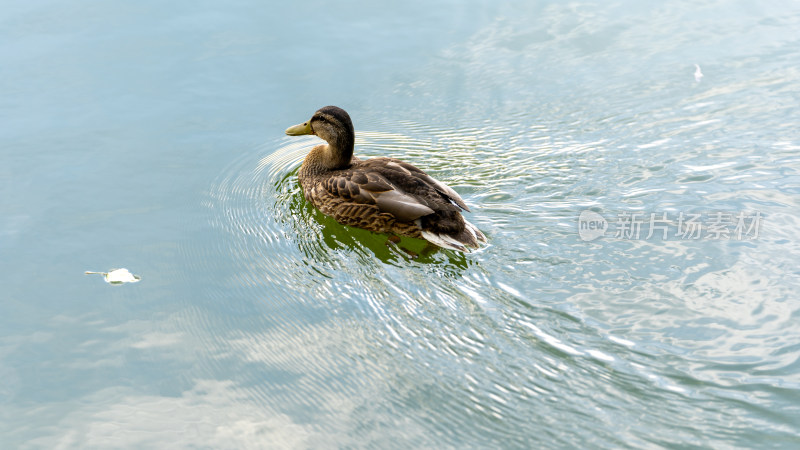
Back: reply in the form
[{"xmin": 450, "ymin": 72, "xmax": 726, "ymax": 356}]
[{"xmin": 286, "ymin": 106, "xmax": 487, "ymax": 253}]
